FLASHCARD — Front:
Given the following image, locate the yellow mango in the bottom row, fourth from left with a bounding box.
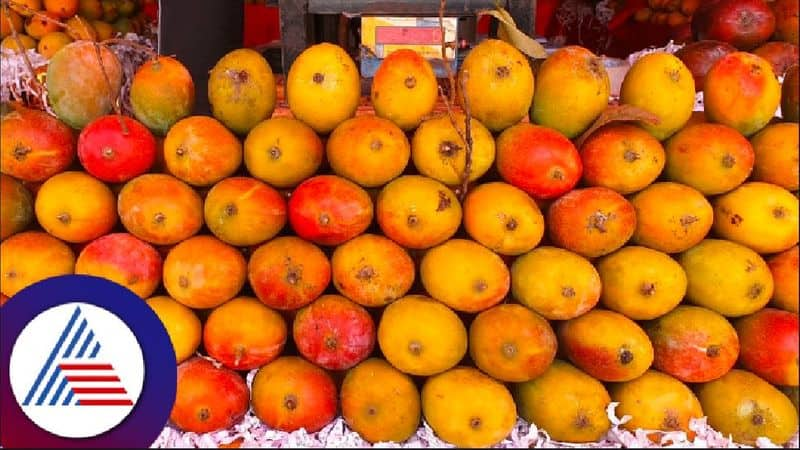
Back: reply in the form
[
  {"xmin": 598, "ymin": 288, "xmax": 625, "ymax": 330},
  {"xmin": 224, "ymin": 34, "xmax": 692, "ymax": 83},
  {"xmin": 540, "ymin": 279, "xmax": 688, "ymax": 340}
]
[{"xmin": 422, "ymin": 366, "xmax": 517, "ymax": 448}]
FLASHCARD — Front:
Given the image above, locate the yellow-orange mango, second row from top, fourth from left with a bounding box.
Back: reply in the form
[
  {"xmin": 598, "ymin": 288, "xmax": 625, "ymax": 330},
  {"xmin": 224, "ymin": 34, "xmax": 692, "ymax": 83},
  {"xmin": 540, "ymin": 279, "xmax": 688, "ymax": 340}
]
[{"xmin": 244, "ymin": 117, "xmax": 325, "ymax": 188}]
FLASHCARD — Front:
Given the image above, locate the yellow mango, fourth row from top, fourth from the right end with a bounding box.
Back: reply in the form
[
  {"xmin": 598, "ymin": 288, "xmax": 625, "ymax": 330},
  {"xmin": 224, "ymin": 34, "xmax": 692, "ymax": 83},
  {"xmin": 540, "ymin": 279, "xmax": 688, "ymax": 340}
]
[{"xmin": 511, "ymin": 246, "xmax": 602, "ymax": 320}]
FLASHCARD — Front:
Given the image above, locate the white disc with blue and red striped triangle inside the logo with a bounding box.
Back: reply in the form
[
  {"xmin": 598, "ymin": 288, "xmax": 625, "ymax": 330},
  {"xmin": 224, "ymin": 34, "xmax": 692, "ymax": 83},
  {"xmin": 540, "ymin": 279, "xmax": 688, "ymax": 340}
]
[{"xmin": 9, "ymin": 302, "xmax": 144, "ymax": 438}]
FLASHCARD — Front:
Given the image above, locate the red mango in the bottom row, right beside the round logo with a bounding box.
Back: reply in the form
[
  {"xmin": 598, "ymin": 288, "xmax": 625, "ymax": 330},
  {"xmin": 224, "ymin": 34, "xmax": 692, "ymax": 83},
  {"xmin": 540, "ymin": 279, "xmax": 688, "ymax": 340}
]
[{"xmin": 169, "ymin": 357, "xmax": 250, "ymax": 433}]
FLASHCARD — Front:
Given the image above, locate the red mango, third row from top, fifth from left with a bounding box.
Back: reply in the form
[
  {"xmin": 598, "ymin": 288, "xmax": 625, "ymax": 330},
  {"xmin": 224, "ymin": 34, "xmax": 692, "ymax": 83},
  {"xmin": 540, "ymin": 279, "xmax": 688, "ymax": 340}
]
[{"xmin": 289, "ymin": 175, "xmax": 372, "ymax": 245}]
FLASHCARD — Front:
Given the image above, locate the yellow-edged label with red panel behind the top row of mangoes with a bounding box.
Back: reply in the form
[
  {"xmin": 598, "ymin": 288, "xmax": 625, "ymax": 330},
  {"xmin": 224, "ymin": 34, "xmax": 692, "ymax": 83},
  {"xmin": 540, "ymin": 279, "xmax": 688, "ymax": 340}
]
[{"xmin": 361, "ymin": 16, "xmax": 458, "ymax": 59}]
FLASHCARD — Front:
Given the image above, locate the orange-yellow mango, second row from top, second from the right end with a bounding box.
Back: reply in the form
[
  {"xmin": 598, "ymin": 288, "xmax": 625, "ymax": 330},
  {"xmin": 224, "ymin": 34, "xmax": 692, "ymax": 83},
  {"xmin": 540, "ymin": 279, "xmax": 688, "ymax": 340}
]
[{"xmin": 665, "ymin": 123, "xmax": 755, "ymax": 195}]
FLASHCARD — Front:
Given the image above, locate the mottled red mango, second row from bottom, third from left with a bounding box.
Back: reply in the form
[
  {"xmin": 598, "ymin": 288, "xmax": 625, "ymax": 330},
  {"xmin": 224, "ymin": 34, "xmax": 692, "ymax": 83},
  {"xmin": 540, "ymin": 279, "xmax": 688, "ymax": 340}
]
[{"xmin": 293, "ymin": 295, "xmax": 375, "ymax": 370}]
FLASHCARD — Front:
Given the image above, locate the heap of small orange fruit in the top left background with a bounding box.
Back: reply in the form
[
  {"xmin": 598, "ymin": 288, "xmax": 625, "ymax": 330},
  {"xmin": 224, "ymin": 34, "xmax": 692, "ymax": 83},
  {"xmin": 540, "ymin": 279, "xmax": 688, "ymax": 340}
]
[{"xmin": 0, "ymin": 0, "xmax": 146, "ymax": 58}]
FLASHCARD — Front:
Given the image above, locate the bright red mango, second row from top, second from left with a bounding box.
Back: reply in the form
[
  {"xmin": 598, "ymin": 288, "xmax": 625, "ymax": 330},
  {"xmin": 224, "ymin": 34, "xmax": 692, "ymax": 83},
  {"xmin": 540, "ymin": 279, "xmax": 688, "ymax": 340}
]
[{"xmin": 78, "ymin": 115, "xmax": 156, "ymax": 183}]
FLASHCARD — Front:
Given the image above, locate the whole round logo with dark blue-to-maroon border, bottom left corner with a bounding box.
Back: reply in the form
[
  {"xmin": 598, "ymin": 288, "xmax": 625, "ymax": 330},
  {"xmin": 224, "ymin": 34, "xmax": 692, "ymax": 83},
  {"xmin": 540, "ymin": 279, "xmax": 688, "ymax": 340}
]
[{"xmin": 0, "ymin": 275, "xmax": 176, "ymax": 448}]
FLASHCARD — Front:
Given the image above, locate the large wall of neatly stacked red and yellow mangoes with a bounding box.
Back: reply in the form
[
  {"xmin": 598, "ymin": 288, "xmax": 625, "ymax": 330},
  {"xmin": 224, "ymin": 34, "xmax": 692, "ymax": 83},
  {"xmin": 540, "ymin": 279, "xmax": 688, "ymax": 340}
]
[{"xmin": 0, "ymin": 30, "xmax": 800, "ymax": 447}]
